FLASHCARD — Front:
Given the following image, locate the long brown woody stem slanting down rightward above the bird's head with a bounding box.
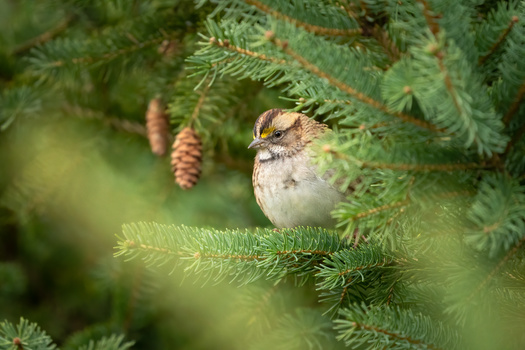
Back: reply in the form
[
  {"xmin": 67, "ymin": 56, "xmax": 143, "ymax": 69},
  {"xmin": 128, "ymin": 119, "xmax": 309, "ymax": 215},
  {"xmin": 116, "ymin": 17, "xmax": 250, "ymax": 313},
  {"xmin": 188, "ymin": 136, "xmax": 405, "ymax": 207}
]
[{"xmin": 271, "ymin": 34, "xmax": 444, "ymax": 132}]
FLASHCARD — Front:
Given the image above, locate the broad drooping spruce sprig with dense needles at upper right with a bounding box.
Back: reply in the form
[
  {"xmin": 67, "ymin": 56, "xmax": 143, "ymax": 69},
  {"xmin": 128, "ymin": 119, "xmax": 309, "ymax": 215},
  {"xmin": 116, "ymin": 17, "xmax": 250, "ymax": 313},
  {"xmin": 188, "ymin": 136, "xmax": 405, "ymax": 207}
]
[{"xmin": 408, "ymin": 35, "xmax": 507, "ymax": 157}]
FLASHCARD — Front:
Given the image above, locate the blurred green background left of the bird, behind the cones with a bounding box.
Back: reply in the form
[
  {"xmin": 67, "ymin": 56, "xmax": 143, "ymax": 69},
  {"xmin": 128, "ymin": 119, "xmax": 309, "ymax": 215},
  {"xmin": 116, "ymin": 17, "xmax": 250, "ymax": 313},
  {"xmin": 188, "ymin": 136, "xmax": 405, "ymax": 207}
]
[{"xmin": 0, "ymin": 0, "xmax": 308, "ymax": 349}]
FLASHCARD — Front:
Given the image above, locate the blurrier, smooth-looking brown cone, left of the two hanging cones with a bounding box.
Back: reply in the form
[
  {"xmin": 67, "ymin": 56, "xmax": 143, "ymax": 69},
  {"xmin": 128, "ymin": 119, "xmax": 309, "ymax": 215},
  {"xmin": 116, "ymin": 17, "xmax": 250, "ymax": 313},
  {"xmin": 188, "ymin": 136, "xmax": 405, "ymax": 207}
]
[{"xmin": 146, "ymin": 98, "xmax": 170, "ymax": 156}]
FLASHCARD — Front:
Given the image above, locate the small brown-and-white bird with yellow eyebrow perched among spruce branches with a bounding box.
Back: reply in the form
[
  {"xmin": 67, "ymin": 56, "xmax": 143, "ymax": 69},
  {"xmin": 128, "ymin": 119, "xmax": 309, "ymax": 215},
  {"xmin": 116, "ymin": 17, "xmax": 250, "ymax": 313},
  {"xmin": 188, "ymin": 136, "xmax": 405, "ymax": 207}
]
[{"xmin": 248, "ymin": 109, "xmax": 345, "ymax": 228}]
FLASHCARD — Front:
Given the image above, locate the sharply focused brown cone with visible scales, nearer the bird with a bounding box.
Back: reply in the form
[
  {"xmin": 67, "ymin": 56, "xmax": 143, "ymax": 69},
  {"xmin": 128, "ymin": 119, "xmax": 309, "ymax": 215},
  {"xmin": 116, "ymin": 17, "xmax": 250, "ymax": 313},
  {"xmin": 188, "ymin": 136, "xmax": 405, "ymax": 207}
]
[{"xmin": 171, "ymin": 127, "xmax": 202, "ymax": 190}]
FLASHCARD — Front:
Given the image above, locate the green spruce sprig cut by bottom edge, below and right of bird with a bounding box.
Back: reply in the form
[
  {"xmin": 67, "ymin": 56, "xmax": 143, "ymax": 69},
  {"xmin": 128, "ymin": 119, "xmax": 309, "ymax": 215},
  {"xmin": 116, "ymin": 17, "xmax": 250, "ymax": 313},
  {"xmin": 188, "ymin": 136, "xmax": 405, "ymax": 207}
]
[{"xmin": 335, "ymin": 304, "xmax": 459, "ymax": 350}]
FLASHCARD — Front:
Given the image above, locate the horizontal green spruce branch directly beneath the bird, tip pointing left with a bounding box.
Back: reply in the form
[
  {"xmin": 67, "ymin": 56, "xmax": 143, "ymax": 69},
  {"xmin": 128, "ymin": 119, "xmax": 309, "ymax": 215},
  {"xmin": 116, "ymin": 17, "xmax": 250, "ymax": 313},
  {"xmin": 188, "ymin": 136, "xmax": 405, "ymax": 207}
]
[{"xmin": 115, "ymin": 223, "xmax": 349, "ymax": 283}]
